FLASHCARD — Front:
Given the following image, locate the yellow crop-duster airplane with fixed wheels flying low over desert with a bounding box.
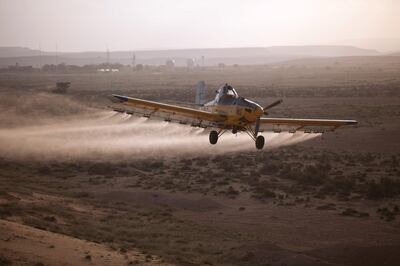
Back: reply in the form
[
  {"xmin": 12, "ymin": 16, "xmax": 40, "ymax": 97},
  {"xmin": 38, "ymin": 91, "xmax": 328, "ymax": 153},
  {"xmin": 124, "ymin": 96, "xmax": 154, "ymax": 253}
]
[{"xmin": 110, "ymin": 81, "xmax": 358, "ymax": 150}]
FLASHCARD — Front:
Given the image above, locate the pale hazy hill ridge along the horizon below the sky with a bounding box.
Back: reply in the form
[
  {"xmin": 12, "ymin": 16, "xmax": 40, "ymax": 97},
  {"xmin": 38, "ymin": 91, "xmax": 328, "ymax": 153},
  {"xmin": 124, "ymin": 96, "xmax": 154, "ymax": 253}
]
[{"xmin": 0, "ymin": 45, "xmax": 379, "ymax": 67}]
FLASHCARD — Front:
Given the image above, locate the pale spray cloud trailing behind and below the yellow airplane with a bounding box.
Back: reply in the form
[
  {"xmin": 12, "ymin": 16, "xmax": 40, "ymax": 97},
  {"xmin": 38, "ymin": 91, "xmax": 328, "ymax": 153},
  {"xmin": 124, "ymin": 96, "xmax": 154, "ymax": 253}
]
[{"xmin": 0, "ymin": 111, "xmax": 318, "ymax": 160}]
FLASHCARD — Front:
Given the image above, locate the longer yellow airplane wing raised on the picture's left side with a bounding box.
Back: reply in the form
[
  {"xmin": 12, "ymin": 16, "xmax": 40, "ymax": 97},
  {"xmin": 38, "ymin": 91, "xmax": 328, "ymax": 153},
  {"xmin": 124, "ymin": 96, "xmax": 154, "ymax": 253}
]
[{"xmin": 112, "ymin": 94, "xmax": 225, "ymax": 127}]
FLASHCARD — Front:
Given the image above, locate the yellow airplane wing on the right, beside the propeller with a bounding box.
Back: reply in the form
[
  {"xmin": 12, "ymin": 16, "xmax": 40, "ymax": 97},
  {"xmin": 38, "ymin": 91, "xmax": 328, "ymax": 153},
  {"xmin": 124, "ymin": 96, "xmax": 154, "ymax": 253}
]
[{"xmin": 260, "ymin": 117, "xmax": 358, "ymax": 131}]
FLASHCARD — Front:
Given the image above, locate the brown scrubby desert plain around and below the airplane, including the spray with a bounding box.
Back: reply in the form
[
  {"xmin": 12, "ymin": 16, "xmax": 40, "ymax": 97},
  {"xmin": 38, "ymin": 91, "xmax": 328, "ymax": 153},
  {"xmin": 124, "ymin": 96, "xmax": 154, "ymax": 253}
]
[{"xmin": 0, "ymin": 56, "xmax": 400, "ymax": 266}]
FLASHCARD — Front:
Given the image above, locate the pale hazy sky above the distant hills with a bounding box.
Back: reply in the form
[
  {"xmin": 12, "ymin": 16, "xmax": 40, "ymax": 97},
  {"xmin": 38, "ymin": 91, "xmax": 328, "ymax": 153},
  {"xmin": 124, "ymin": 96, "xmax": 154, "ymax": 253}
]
[{"xmin": 0, "ymin": 0, "xmax": 400, "ymax": 51}]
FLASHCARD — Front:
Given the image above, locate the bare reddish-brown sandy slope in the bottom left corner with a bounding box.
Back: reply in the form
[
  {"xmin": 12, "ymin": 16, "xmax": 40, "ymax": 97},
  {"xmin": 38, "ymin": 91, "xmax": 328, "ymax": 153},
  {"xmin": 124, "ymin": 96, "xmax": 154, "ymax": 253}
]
[{"xmin": 0, "ymin": 219, "xmax": 171, "ymax": 265}]
